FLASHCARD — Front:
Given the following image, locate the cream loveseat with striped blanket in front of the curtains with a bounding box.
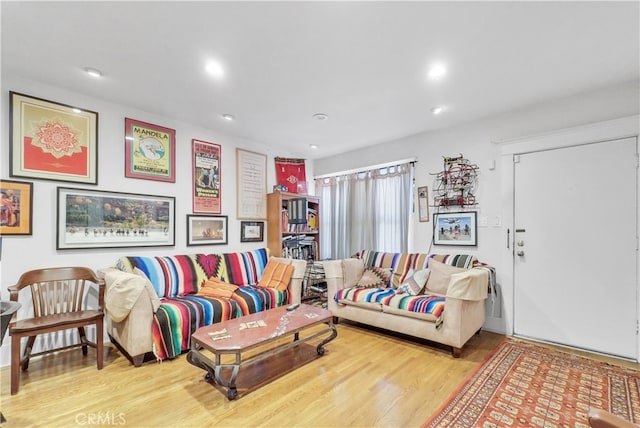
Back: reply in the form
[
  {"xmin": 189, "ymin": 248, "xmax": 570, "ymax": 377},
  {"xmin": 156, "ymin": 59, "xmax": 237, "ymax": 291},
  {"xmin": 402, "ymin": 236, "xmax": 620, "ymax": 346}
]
[{"xmin": 323, "ymin": 250, "xmax": 495, "ymax": 358}]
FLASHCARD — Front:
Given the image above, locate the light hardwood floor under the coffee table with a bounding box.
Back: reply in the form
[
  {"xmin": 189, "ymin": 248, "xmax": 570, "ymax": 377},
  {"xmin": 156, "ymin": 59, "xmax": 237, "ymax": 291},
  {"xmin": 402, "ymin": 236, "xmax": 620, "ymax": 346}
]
[{"xmin": 6, "ymin": 322, "xmax": 640, "ymax": 428}]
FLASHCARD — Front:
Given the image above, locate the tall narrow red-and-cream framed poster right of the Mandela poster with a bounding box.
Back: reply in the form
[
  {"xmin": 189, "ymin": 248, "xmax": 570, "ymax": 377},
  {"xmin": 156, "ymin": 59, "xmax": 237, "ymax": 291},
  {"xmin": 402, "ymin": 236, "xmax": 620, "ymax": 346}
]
[{"xmin": 191, "ymin": 139, "xmax": 222, "ymax": 214}]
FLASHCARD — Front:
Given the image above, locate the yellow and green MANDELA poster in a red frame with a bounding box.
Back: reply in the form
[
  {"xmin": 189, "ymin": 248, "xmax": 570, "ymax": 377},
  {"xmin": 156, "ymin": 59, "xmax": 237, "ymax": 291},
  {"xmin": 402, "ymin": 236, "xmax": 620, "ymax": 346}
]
[{"xmin": 124, "ymin": 118, "xmax": 176, "ymax": 183}]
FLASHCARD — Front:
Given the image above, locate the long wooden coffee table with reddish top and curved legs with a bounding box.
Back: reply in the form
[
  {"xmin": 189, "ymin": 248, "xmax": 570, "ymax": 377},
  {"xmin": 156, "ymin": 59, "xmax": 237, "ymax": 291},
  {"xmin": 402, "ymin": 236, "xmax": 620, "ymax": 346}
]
[{"xmin": 187, "ymin": 304, "xmax": 338, "ymax": 400}]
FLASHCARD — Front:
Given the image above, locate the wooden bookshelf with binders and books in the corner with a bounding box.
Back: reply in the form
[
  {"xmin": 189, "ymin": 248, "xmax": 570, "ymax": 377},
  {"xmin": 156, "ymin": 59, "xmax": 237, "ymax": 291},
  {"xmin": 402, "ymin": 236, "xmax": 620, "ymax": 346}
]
[{"xmin": 267, "ymin": 192, "xmax": 320, "ymax": 260}]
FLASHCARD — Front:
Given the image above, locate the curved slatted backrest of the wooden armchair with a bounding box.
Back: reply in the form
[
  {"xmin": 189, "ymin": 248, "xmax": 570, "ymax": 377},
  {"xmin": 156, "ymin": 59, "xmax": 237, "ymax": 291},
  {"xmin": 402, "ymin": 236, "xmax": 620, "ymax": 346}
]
[{"xmin": 9, "ymin": 267, "xmax": 103, "ymax": 317}]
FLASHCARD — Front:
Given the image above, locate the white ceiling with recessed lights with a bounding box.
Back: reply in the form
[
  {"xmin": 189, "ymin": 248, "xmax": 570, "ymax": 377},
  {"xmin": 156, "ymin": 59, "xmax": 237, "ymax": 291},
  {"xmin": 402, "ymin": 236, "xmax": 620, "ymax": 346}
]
[{"xmin": 2, "ymin": 1, "xmax": 640, "ymax": 159}]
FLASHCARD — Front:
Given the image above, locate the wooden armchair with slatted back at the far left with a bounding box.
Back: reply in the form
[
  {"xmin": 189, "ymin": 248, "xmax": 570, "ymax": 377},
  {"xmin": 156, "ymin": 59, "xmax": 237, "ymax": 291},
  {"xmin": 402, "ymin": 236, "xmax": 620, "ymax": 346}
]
[{"xmin": 9, "ymin": 267, "xmax": 105, "ymax": 395}]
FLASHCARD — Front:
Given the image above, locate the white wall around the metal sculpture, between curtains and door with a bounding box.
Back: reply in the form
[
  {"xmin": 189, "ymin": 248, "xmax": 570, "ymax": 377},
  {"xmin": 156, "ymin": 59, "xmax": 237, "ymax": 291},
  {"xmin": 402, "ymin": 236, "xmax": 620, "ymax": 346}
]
[{"xmin": 314, "ymin": 80, "xmax": 640, "ymax": 333}]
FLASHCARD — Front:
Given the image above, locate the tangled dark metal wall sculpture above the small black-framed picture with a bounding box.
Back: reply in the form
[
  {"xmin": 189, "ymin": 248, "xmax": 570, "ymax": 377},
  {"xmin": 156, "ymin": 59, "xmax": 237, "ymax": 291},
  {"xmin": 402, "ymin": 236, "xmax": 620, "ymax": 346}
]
[{"xmin": 432, "ymin": 154, "xmax": 479, "ymax": 207}]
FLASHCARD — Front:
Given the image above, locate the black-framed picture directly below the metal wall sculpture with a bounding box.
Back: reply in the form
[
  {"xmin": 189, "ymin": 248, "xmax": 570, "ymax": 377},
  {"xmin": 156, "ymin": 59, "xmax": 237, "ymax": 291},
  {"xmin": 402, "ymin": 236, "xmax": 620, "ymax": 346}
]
[{"xmin": 433, "ymin": 211, "xmax": 478, "ymax": 246}]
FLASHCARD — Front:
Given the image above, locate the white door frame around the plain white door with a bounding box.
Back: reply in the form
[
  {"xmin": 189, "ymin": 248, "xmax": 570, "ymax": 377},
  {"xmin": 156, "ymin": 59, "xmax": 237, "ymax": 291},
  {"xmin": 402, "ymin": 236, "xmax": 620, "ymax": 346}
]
[{"xmin": 493, "ymin": 115, "xmax": 640, "ymax": 359}]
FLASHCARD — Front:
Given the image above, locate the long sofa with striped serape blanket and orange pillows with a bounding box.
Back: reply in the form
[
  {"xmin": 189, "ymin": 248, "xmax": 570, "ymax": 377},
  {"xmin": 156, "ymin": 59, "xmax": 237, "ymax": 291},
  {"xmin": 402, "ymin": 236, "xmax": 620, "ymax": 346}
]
[{"xmin": 98, "ymin": 248, "xmax": 306, "ymax": 367}]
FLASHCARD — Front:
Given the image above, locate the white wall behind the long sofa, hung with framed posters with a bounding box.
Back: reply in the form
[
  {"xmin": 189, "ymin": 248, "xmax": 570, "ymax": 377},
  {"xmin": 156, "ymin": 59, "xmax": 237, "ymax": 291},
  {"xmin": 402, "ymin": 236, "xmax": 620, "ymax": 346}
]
[{"xmin": 0, "ymin": 74, "xmax": 313, "ymax": 366}]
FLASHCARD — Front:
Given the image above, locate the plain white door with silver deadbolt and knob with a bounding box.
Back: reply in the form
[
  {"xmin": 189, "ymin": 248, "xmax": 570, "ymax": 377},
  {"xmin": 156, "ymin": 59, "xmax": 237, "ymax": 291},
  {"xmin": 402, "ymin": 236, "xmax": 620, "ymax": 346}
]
[{"xmin": 514, "ymin": 138, "xmax": 638, "ymax": 360}]
